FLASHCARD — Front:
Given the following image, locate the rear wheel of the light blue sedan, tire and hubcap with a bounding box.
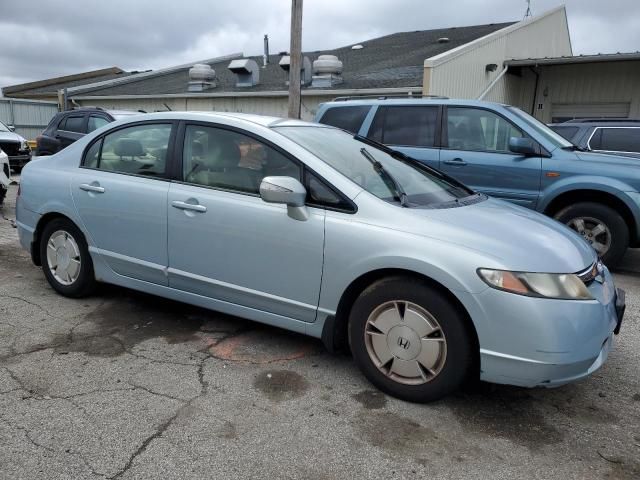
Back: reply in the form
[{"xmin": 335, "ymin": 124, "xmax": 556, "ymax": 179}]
[{"xmin": 40, "ymin": 218, "xmax": 96, "ymax": 298}]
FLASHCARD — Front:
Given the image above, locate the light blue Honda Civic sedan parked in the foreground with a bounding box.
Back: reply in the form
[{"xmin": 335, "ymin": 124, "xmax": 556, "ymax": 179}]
[{"xmin": 17, "ymin": 112, "xmax": 625, "ymax": 402}]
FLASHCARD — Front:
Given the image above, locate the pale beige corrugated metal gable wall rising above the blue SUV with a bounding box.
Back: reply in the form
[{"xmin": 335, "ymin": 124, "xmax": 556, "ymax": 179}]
[{"xmin": 425, "ymin": 10, "xmax": 571, "ymax": 102}]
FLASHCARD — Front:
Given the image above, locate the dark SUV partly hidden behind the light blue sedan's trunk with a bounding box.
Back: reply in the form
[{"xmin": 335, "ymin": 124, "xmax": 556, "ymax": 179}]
[{"xmin": 36, "ymin": 107, "xmax": 146, "ymax": 155}]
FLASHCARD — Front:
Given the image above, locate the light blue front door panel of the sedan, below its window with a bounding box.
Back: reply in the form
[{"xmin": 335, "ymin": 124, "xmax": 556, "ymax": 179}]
[{"xmin": 167, "ymin": 183, "xmax": 324, "ymax": 322}]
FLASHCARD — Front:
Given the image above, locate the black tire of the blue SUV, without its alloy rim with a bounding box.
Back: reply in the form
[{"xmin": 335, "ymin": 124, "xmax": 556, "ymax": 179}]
[{"xmin": 554, "ymin": 202, "xmax": 629, "ymax": 268}]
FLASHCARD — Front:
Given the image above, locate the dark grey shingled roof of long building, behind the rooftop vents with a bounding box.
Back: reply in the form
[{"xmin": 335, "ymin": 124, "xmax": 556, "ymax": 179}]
[{"xmin": 69, "ymin": 23, "xmax": 512, "ymax": 97}]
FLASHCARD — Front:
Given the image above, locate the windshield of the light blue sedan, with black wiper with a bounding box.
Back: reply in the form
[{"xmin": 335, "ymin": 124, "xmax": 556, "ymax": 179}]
[{"xmin": 275, "ymin": 126, "xmax": 475, "ymax": 207}]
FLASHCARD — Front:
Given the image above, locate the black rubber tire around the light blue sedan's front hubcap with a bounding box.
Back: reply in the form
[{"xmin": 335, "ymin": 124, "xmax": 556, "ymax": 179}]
[{"xmin": 349, "ymin": 277, "xmax": 475, "ymax": 403}]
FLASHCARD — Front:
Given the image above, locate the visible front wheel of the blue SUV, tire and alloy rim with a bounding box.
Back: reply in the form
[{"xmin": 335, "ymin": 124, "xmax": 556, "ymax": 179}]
[{"xmin": 555, "ymin": 202, "xmax": 629, "ymax": 267}]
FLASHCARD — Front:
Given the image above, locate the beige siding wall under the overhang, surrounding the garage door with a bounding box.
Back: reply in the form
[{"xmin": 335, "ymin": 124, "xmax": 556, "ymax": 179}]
[{"xmin": 536, "ymin": 61, "xmax": 640, "ymax": 122}]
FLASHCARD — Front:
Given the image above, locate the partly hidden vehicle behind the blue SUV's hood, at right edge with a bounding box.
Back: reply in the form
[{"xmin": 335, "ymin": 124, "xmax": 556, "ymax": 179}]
[{"xmin": 549, "ymin": 118, "xmax": 640, "ymax": 158}]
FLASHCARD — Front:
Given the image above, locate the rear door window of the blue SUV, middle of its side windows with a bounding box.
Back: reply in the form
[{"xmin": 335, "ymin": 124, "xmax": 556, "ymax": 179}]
[{"xmin": 367, "ymin": 106, "xmax": 439, "ymax": 147}]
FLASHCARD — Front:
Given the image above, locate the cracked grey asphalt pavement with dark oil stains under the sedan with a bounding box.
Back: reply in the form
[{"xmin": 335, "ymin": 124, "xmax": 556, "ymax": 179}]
[{"xmin": 0, "ymin": 178, "xmax": 640, "ymax": 479}]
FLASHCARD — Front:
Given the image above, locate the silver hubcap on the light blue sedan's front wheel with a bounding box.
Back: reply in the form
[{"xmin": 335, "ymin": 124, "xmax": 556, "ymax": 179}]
[{"xmin": 364, "ymin": 300, "xmax": 447, "ymax": 385}]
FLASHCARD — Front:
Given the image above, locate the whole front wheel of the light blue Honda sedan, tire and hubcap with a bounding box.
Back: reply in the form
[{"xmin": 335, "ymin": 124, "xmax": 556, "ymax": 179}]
[{"xmin": 349, "ymin": 277, "xmax": 474, "ymax": 402}]
